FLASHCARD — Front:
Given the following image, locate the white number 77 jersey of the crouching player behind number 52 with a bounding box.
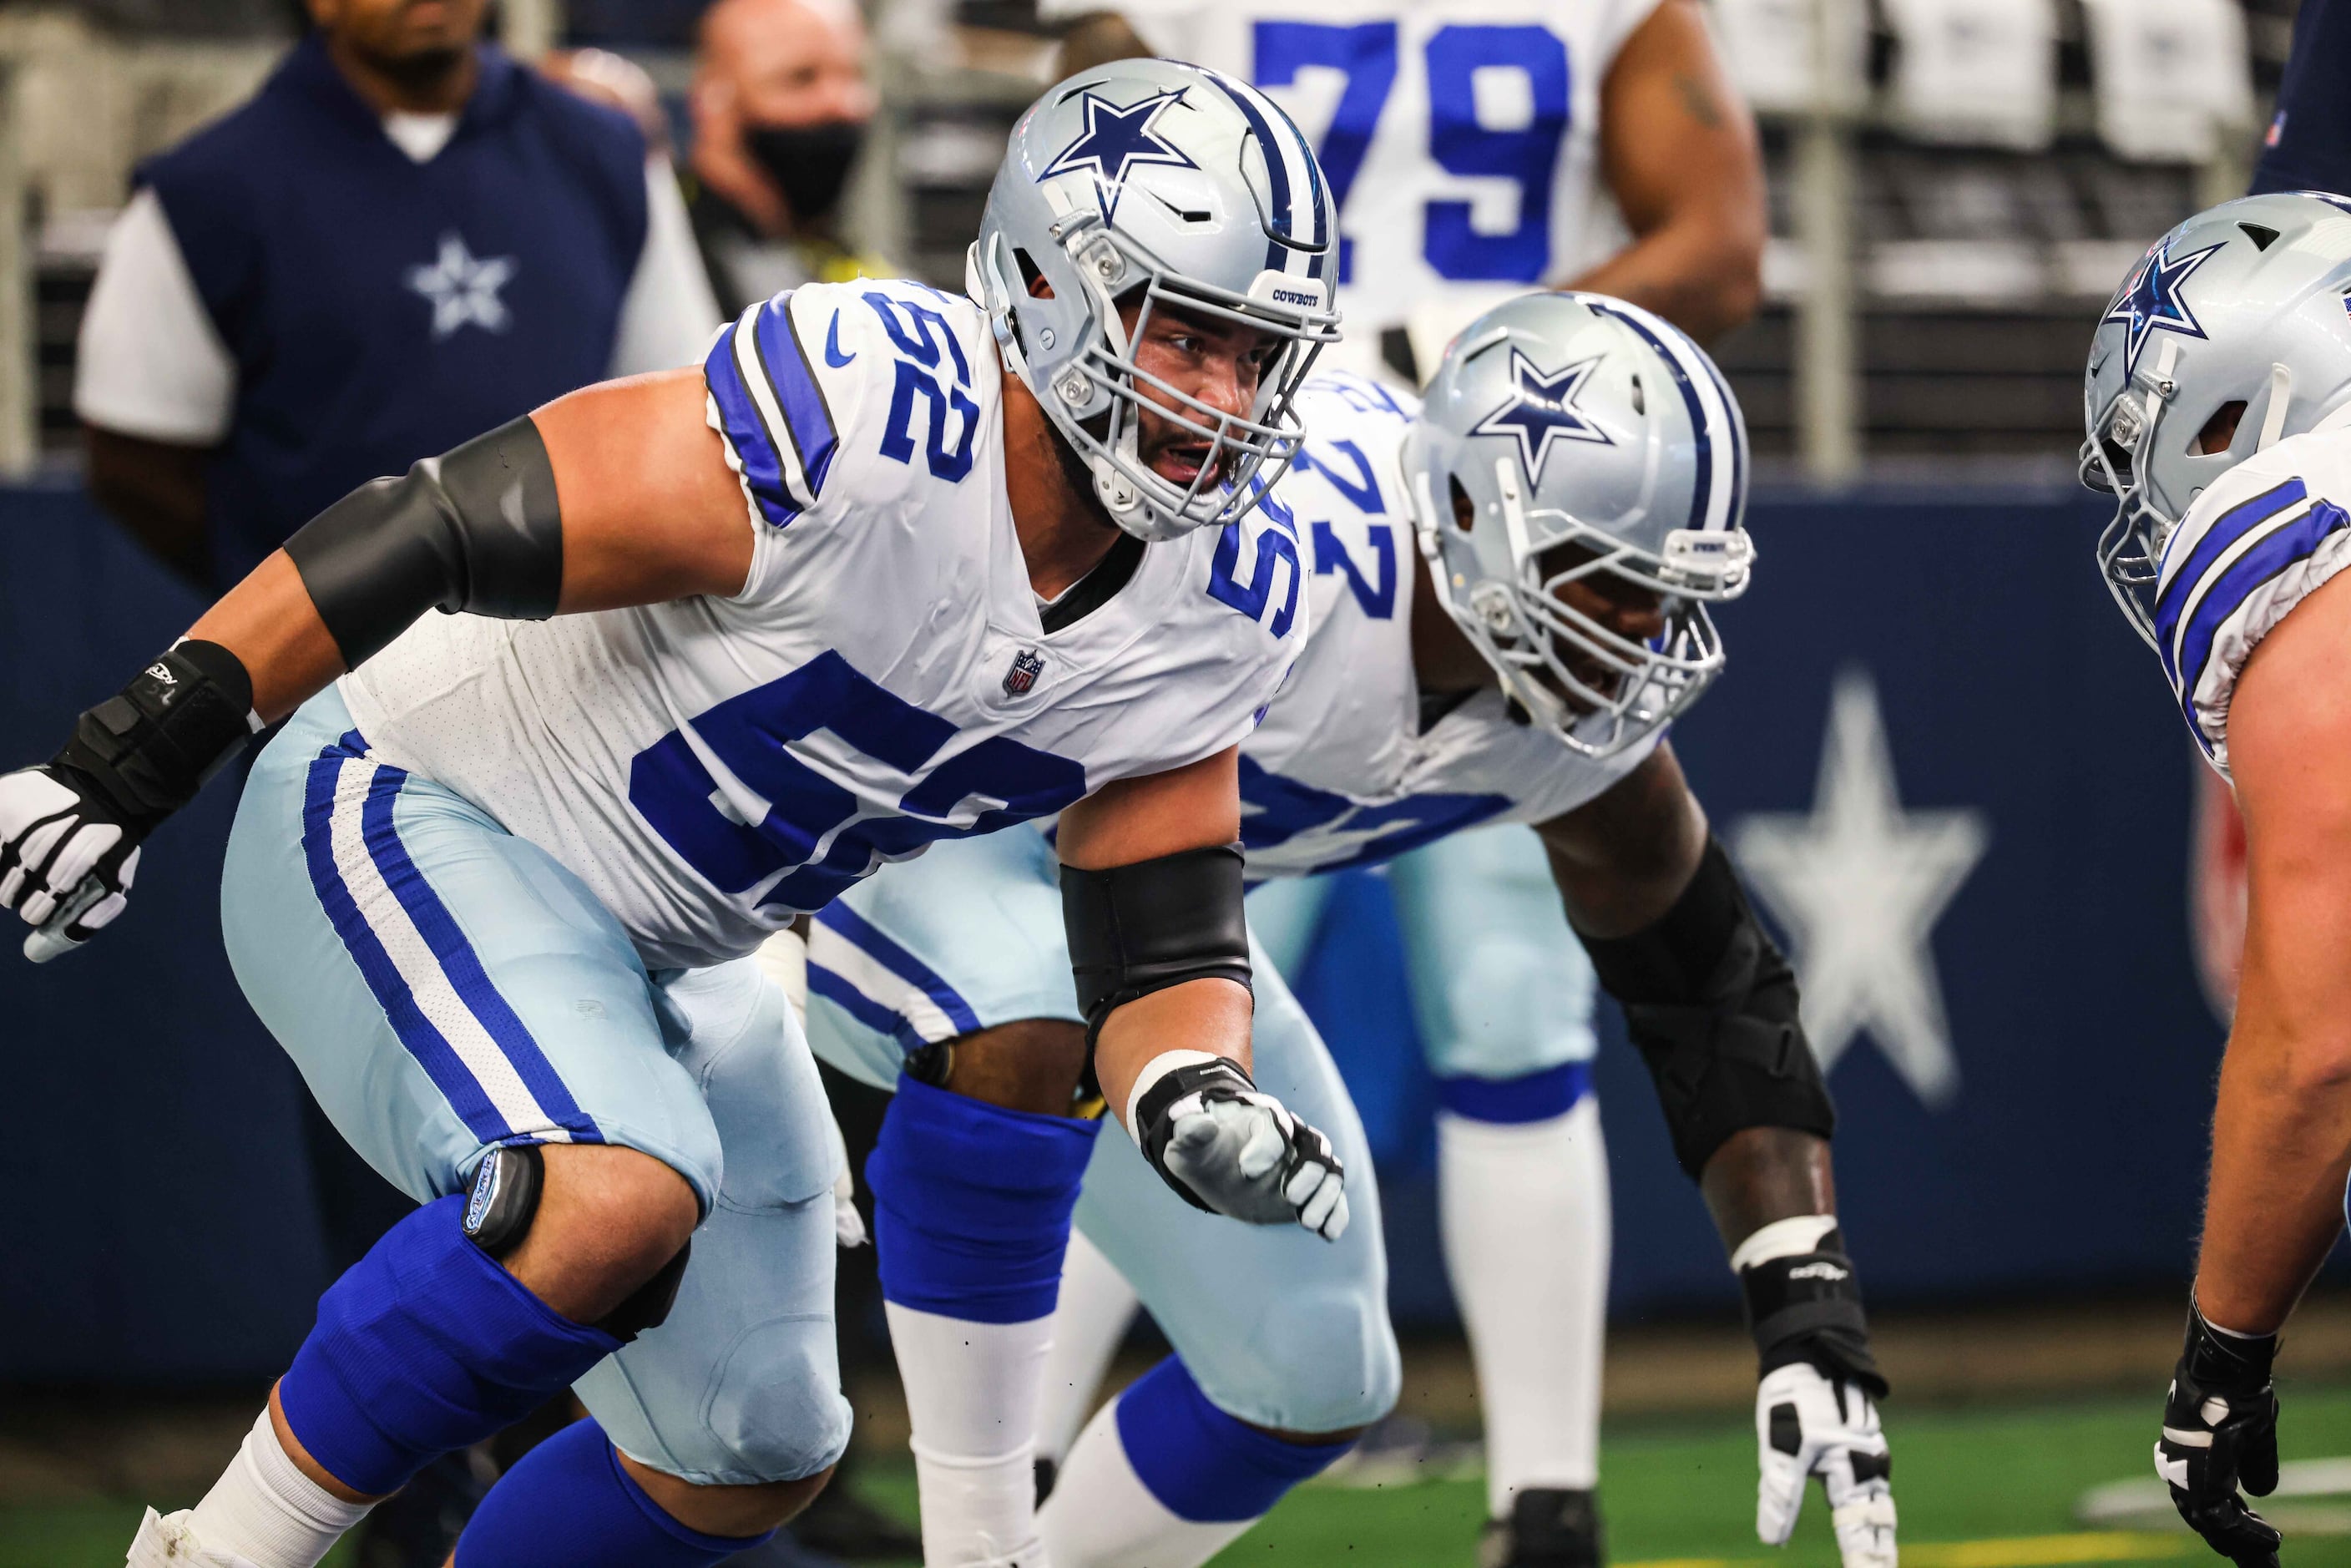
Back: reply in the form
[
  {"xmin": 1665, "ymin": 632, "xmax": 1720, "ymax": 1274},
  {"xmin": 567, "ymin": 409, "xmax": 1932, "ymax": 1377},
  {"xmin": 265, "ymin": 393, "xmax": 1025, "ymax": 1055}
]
[{"xmin": 1241, "ymin": 374, "xmax": 1657, "ymax": 879}]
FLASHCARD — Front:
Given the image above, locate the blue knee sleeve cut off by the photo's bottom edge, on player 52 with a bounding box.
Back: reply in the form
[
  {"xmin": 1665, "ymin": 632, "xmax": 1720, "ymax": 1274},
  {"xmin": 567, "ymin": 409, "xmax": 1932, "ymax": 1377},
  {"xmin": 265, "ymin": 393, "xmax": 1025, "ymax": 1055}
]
[{"xmin": 456, "ymin": 1415, "xmax": 773, "ymax": 1568}]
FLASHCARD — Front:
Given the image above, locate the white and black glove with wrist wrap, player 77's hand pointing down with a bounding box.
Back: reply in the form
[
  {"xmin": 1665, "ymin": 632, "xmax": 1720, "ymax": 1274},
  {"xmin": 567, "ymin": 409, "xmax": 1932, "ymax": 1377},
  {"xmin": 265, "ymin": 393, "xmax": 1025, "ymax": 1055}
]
[{"xmin": 1732, "ymin": 1216, "xmax": 1895, "ymax": 1568}]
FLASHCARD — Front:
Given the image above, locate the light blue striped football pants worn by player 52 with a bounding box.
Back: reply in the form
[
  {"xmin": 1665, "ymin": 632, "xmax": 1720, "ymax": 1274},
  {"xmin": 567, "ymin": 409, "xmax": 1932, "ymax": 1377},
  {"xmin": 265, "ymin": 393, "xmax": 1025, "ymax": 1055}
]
[{"xmin": 221, "ymin": 689, "xmax": 849, "ymax": 1484}]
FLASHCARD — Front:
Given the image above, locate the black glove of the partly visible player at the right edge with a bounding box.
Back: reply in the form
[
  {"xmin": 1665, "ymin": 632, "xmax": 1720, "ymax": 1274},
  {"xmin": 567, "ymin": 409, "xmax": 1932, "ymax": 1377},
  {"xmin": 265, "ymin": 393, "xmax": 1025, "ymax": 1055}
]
[{"xmin": 2156, "ymin": 1302, "xmax": 2285, "ymax": 1568}]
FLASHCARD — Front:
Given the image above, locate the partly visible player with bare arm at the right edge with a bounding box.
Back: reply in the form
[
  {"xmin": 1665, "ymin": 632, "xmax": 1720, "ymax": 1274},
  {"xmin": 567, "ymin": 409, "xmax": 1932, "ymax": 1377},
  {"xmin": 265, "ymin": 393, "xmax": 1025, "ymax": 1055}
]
[{"xmin": 2081, "ymin": 193, "xmax": 2351, "ymax": 1568}]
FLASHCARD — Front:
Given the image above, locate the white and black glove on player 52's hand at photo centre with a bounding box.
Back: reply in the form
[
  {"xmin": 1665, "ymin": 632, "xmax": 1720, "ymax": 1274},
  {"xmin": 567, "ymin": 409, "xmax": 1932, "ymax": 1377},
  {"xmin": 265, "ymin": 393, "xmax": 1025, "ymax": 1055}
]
[{"xmin": 1126, "ymin": 1051, "xmax": 1347, "ymax": 1242}]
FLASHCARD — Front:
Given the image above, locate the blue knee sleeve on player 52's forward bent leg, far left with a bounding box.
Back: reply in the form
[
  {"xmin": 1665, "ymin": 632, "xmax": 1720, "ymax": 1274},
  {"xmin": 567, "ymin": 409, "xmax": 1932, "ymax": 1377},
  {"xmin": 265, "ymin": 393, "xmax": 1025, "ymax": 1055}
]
[{"xmin": 277, "ymin": 1194, "xmax": 620, "ymax": 1493}]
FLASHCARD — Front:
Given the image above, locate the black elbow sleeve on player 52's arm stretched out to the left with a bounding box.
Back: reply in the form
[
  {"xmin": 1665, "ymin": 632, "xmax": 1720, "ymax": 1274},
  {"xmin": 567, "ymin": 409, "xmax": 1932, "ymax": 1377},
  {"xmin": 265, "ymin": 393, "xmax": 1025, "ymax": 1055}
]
[{"xmin": 285, "ymin": 416, "xmax": 564, "ymax": 670}]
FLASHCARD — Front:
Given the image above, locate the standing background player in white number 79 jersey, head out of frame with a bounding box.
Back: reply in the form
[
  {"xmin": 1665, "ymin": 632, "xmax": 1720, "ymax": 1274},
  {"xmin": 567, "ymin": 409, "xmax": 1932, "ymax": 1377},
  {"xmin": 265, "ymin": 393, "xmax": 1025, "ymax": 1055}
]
[{"xmin": 1046, "ymin": 0, "xmax": 1766, "ymax": 1554}]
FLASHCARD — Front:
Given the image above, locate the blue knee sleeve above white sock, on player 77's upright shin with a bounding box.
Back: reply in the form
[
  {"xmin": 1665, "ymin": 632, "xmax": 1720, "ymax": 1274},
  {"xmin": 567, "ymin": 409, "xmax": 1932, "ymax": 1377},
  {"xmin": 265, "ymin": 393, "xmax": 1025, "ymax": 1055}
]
[{"xmin": 865, "ymin": 1079, "xmax": 1100, "ymax": 1323}]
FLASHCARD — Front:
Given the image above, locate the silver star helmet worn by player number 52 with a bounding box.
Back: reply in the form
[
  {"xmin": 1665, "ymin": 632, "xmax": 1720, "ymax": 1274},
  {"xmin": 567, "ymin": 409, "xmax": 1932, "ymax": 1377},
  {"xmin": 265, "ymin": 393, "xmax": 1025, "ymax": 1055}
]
[{"xmin": 968, "ymin": 58, "xmax": 1337, "ymax": 539}]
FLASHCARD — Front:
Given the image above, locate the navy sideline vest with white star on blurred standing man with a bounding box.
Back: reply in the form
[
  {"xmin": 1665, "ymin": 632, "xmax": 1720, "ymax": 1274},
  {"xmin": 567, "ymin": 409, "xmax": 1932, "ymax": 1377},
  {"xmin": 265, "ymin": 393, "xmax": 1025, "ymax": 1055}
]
[{"xmin": 139, "ymin": 33, "xmax": 646, "ymax": 590}]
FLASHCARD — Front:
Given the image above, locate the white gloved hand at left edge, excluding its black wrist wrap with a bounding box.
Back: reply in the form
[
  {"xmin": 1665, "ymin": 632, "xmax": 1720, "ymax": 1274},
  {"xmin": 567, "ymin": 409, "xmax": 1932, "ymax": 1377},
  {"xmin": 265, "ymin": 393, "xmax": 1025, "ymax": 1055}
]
[{"xmin": 0, "ymin": 766, "xmax": 139, "ymax": 964}]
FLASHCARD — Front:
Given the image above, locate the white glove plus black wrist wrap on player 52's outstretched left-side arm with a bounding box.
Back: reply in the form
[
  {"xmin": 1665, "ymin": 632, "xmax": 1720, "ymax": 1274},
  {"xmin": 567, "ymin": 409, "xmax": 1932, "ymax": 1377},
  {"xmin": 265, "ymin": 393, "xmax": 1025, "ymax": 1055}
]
[{"xmin": 0, "ymin": 642, "xmax": 261, "ymax": 964}]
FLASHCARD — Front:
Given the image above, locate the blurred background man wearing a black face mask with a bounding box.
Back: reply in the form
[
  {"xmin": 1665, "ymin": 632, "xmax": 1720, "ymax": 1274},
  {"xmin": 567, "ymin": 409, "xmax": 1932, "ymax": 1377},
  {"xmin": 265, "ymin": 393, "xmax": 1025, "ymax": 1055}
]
[{"xmin": 686, "ymin": 0, "xmax": 887, "ymax": 315}]
